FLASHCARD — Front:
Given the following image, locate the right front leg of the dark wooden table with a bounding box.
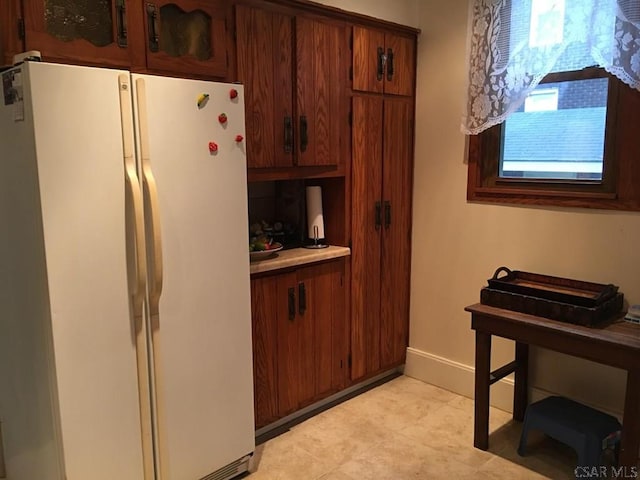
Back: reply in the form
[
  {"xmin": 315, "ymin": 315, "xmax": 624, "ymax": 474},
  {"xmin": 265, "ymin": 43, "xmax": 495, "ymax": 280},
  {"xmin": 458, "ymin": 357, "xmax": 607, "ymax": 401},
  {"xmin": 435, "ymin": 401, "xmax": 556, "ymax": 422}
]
[{"xmin": 619, "ymin": 370, "xmax": 640, "ymax": 467}]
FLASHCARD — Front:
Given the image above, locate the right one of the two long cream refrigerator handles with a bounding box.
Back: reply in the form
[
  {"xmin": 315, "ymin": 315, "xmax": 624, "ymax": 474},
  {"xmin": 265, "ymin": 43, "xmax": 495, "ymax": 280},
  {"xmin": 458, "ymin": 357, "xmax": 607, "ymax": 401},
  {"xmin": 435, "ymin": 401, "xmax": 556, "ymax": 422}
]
[{"xmin": 136, "ymin": 78, "xmax": 163, "ymax": 316}]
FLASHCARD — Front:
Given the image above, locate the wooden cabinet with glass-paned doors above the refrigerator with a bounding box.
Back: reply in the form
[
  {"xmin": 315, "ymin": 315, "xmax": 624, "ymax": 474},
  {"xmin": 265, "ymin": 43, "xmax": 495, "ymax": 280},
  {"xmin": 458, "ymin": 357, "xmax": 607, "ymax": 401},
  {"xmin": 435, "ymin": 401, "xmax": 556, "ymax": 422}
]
[{"xmin": 2, "ymin": 0, "xmax": 231, "ymax": 79}]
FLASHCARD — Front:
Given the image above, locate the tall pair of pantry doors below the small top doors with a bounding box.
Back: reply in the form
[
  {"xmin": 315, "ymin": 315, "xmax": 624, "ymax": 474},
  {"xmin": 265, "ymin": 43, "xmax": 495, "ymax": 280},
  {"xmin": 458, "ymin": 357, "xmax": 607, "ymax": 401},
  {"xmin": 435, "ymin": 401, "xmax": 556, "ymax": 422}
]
[{"xmin": 351, "ymin": 95, "xmax": 414, "ymax": 381}]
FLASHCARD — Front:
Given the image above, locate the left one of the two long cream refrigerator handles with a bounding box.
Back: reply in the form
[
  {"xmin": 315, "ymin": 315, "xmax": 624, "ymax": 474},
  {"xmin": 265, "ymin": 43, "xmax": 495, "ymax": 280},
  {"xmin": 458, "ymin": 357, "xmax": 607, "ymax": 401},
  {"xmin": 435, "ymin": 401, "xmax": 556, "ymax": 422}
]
[{"xmin": 118, "ymin": 74, "xmax": 147, "ymax": 317}]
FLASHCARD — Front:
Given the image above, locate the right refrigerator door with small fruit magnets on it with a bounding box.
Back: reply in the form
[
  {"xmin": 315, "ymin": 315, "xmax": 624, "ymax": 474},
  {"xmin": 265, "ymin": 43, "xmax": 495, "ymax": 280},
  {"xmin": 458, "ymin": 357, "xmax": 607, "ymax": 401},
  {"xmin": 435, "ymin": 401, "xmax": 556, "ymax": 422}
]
[{"xmin": 133, "ymin": 75, "xmax": 254, "ymax": 480}]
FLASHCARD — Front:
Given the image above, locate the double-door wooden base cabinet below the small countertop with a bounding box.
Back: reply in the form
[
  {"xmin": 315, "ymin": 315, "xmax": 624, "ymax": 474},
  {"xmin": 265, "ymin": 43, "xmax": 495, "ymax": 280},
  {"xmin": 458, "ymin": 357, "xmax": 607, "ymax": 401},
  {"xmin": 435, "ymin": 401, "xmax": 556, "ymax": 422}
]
[{"xmin": 251, "ymin": 259, "xmax": 349, "ymax": 428}]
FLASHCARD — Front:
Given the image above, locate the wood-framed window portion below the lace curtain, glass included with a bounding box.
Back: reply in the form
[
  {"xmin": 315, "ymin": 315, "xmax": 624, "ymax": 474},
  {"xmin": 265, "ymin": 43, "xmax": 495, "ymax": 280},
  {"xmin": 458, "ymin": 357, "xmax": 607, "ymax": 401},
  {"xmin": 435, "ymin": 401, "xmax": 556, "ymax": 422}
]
[{"xmin": 467, "ymin": 68, "xmax": 640, "ymax": 210}]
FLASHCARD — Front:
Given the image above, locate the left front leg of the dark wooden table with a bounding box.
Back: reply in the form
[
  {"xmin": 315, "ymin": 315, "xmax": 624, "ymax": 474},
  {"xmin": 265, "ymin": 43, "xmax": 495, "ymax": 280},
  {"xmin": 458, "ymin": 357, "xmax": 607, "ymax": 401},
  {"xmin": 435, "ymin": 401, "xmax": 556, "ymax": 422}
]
[{"xmin": 473, "ymin": 330, "xmax": 491, "ymax": 450}]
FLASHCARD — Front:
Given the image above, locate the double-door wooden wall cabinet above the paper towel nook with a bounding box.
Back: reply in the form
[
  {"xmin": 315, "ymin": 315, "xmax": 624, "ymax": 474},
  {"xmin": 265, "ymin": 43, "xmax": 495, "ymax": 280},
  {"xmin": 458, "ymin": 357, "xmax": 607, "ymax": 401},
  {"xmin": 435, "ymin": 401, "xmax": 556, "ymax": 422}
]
[{"xmin": 236, "ymin": 5, "xmax": 348, "ymax": 172}]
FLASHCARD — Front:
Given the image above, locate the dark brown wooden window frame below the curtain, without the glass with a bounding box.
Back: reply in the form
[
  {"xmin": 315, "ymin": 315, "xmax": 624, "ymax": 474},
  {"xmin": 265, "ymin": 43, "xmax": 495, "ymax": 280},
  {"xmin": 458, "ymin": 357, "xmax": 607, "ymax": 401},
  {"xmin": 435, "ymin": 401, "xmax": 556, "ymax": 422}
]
[{"xmin": 467, "ymin": 67, "xmax": 640, "ymax": 211}]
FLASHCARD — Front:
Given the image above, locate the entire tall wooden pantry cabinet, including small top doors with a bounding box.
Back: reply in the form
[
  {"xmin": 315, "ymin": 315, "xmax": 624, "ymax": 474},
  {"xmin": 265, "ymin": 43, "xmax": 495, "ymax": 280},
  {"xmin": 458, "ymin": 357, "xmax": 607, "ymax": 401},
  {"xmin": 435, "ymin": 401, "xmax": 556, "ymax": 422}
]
[{"xmin": 351, "ymin": 26, "xmax": 416, "ymax": 381}]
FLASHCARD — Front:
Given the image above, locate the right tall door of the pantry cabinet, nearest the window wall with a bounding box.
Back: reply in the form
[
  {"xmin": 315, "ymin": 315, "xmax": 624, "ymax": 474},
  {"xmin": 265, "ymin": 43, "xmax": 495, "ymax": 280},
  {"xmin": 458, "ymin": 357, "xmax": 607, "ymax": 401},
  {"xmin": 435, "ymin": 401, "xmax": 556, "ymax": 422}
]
[{"xmin": 380, "ymin": 98, "xmax": 413, "ymax": 369}]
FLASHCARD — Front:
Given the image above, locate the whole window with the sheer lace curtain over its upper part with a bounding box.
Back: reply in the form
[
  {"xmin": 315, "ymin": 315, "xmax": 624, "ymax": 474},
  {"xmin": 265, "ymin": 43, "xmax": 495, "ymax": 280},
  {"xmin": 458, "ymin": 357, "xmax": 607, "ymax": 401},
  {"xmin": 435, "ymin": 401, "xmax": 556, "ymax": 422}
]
[{"xmin": 463, "ymin": 0, "xmax": 640, "ymax": 210}]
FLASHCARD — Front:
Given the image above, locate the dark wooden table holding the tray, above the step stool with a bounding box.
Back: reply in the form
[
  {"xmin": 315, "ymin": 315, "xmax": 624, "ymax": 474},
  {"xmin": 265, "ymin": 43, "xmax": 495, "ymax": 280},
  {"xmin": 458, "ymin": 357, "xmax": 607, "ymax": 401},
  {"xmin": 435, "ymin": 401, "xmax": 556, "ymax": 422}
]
[{"xmin": 465, "ymin": 303, "xmax": 640, "ymax": 466}]
